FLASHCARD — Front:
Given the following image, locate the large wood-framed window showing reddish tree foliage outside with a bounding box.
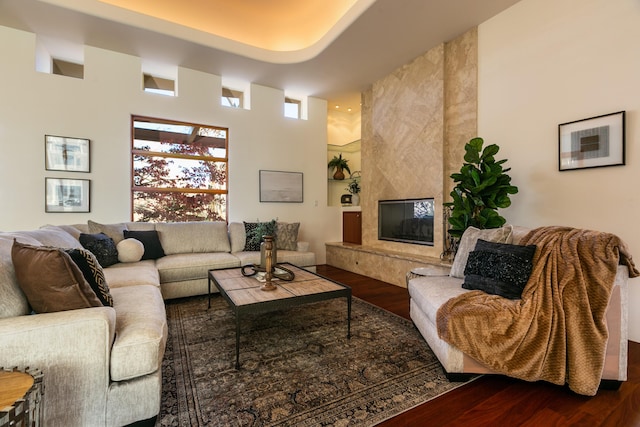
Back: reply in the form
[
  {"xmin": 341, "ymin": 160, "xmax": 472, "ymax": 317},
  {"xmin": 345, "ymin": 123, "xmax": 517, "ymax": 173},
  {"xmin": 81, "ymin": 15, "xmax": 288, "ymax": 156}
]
[{"xmin": 131, "ymin": 116, "xmax": 229, "ymax": 222}]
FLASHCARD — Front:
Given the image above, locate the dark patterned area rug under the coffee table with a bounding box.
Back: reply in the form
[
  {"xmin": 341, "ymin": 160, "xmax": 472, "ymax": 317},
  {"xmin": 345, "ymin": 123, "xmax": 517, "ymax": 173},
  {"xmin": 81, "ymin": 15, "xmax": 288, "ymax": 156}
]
[{"xmin": 157, "ymin": 295, "xmax": 472, "ymax": 426}]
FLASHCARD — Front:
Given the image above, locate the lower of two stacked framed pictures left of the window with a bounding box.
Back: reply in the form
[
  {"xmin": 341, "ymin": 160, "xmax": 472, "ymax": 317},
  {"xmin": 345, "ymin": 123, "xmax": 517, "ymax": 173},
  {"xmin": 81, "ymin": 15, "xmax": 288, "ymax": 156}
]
[{"xmin": 45, "ymin": 178, "xmax": 91, "ymax": 212}]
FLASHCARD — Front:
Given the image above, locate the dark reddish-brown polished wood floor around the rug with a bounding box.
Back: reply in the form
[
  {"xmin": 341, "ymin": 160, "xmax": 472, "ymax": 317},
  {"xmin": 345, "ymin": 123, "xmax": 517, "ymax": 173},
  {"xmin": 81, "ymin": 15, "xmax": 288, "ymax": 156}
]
[{"xmin": 317, "ymin": 265, "xmax": 640, "ymax": 427}]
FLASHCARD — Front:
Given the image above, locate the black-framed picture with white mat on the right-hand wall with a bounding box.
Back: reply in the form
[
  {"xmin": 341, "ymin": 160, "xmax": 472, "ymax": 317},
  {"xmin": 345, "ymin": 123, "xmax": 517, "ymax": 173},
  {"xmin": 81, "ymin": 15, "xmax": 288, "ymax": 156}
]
[{"xmin": 558, "ymin": 111, "xmax": 625, "ymax": 171}]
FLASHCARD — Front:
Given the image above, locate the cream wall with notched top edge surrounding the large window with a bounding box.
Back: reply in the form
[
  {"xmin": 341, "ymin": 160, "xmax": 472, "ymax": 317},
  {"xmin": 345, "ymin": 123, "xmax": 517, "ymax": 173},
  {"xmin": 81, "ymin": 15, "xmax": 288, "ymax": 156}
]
[{"xmin": 0, "ymin": 27, "xmax": 341, "ymax": 263}]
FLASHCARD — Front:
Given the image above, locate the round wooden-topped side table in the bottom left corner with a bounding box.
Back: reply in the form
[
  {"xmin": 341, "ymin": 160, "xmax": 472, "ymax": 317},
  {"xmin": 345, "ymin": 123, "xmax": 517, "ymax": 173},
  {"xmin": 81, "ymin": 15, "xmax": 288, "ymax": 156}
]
[{"xmin": 0, "ymin": 368, "xmax": 43, "ymax": 427}]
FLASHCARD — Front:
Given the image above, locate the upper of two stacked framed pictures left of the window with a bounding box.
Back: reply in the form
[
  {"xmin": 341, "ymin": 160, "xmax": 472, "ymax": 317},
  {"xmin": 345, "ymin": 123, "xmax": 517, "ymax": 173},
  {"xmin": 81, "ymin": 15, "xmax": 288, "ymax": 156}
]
[{"xmin": 44, "ymin": 135, "xmax": 91, "ymax": 172}]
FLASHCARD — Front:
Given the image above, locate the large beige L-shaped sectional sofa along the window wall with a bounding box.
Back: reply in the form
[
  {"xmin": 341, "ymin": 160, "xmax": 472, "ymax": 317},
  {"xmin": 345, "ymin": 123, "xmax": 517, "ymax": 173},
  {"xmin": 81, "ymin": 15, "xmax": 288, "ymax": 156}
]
[{"xmin": 0, "ymin": 222, "xmax": 315, "ymax": 427}]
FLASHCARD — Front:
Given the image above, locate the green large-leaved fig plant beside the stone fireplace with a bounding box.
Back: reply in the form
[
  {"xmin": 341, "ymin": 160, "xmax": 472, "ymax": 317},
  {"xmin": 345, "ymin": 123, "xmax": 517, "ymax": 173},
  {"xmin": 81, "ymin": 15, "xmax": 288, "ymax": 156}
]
[{"xmin": 444, "ymin": 138, "xmax": 518, "ymax": 239}]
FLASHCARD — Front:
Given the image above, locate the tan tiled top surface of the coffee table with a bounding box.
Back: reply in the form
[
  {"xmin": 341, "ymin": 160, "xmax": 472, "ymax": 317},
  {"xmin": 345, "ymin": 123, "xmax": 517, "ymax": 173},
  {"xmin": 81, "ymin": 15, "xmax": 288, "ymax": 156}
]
[{"xmin": 209, "ymin": 265, "xmax": 346, "ymax": 307}]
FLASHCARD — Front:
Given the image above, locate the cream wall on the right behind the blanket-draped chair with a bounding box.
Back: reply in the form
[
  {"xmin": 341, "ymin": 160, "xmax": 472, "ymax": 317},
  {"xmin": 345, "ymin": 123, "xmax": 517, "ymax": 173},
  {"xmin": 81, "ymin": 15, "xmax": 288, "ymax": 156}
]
[{"xmin": 478, "ymin": 0, "xmax": 640, "ymax": 341}]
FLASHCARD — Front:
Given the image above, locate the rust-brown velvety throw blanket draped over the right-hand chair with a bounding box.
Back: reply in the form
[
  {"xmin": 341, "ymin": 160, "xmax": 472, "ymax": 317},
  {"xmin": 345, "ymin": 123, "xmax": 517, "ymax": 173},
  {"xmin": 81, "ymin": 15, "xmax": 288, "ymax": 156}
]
[{"xmin": 437, "ymin": 227, "xmax": 640, "ymax": 396}]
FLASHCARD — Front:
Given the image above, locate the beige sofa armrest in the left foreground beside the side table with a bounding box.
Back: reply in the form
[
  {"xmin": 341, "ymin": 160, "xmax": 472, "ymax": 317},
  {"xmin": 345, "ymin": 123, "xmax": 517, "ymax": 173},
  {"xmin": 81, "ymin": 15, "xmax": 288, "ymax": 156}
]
[{"xmin": 0, "ymin": 307, "xmax": 116, "ymax": 426}]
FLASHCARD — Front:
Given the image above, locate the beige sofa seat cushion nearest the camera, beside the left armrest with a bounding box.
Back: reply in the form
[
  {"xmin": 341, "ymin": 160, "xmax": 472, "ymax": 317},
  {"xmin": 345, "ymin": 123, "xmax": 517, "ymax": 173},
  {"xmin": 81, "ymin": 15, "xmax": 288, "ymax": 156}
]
[{"xmin": 110, "ymin": 286, "xmax": 167, "ymax": 381}]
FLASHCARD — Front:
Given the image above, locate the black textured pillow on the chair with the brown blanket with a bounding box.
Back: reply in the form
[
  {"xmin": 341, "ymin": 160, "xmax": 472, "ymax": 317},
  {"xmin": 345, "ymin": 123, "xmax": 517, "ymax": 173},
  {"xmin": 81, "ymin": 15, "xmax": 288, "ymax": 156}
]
[{"xmin": 462, "ymin": 240, "xmax": 536, "ymax": 299}]
